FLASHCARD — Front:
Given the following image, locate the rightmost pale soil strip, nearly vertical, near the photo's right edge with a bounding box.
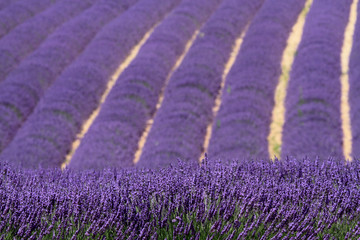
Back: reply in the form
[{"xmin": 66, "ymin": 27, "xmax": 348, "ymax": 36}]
[{"xmin": 340, "ymin": 0, "xmax": 358, "ymax": 161}]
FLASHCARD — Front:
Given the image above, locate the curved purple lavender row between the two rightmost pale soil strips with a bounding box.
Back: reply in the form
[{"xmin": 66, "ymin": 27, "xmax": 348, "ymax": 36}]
[{"xmin": 281, "ymin": 0, "xmax": 352, "ymax": 159}]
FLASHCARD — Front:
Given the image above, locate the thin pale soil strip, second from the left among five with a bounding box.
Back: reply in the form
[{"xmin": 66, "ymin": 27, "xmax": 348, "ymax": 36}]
[{"xmin": 133, "ymin": 30, "xmax": 199, "ymax": 164}]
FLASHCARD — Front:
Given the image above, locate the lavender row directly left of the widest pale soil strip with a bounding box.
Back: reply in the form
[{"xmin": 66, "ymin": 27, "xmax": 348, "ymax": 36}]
[{"xmin": 208, "ymin": 0, "xmax": 305, "ymax": 162}]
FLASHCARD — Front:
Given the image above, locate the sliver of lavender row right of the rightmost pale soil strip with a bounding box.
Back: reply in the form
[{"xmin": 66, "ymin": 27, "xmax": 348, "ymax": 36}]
[{"xmin": 349, "ymin": 4, "xmax": 360, "ymax": 158}]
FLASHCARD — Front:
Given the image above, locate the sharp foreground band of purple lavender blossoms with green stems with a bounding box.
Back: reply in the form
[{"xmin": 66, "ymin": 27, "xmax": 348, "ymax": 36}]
[{"xmin": 0, "ymin": 158, "xmax": 360, "ymax": 240}]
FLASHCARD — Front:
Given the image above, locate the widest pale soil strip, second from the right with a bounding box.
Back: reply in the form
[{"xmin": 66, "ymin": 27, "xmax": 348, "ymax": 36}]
[{"xmin": 268, "ymin": 0, "xmax": 313, "ymax": 161}]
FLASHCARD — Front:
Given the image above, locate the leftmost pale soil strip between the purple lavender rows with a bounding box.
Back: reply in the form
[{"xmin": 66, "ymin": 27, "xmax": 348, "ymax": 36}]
[{"xmin": 61, "ymin": 24, "xmax": 157, "ymax": 170}]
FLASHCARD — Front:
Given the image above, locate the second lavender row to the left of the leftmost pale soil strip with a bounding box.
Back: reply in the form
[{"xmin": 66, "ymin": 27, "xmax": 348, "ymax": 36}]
[{"xmin": 0, "ymin": 0, "xmax": 137, "ymax": 152}]
